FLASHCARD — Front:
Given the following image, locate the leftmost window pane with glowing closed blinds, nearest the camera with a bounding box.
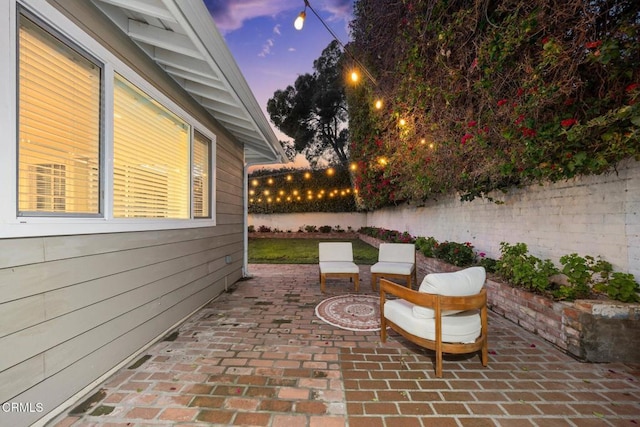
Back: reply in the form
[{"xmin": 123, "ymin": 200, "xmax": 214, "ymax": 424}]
[{"xmin": 18, "ymin": 15, "xmax": 102, "ymax": 216}]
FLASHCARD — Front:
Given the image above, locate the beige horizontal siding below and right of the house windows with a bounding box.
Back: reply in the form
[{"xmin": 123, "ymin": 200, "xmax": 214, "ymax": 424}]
[{"xmin": 0, "ymin": 139, "xmax": 244, "ymax": 426}]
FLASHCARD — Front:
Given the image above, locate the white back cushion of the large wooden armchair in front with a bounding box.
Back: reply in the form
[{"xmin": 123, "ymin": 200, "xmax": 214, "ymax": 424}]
[{"xmin": 413, "ymin": 267, "xmax": 487, "ymax": 319}]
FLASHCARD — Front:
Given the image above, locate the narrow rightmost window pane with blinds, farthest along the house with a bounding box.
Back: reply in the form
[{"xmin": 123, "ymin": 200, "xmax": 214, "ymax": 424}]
[{"xmin": 192, "ymin": 131, "xmax": 211, "ymax": 218}]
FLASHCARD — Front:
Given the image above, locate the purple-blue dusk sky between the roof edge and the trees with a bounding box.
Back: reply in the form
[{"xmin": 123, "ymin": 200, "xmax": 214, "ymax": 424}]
[{"xmin": 204, "ymin": 0, "xmax": 353, "ymax": 167}]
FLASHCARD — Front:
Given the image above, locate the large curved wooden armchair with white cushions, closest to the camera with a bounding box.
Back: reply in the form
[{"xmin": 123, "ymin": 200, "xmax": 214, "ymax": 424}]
[{"xmin": 380, "ymin": 267, "xmax": 488, "ymax": 377}]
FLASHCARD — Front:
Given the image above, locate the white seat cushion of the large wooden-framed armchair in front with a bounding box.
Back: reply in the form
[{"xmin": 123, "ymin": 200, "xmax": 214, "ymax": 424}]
[{"xmin": 384, "ymin": 299, "xmax": 482, "ymax": 343}]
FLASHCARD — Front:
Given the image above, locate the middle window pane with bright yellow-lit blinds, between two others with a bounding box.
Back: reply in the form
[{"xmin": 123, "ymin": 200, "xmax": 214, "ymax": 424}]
[{"xmin": 113, "ymin": 75, "xmax": 191, "ymax": 218}]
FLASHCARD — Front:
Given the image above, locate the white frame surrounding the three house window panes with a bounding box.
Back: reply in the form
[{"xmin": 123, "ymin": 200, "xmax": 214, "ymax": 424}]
[{"xmin": 0, "ymin": 0, "xmax": 217, "ymax": 238}]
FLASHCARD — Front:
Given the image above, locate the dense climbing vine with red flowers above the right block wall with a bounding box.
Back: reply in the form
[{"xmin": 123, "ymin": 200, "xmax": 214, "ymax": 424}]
[{"xmin": 348, "ymin": 0, "xmax": 640, "ymax": 209}]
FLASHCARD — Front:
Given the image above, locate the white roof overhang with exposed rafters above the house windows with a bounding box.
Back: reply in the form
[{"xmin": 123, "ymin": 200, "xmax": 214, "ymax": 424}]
[{"xmin": 92, "ymin": 0, "xmax": 286, "ymax": 163}]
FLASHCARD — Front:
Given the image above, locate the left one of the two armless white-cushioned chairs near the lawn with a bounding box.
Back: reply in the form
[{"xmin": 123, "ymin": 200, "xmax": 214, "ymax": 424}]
[{"xmin": 318, "ymin": 242, "xmax": 360, "ymax": 292}]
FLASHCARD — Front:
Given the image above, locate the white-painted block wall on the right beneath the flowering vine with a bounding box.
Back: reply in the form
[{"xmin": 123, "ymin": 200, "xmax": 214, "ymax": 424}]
[{"xmin": 366, "ymin": 161, "xmax": 640, "ymax": 281}]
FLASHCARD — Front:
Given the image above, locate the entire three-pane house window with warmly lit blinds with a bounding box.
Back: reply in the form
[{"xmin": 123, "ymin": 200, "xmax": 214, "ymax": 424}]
[{"xmin": 16, "ymin": 10, "xmax": 215, "ymax": 229}]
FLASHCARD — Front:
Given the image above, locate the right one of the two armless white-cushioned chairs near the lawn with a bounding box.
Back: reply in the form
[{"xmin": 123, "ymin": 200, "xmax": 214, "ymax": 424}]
[{"xmin": 371, "ymin": 243, "xmax": 418, "ymax": 291}]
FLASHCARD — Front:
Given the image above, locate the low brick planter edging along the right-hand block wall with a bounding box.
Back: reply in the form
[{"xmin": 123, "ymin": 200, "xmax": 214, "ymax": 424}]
[{"xmin": 360, "ymin": 234, "xmax": 640, "ymax": 363}]
